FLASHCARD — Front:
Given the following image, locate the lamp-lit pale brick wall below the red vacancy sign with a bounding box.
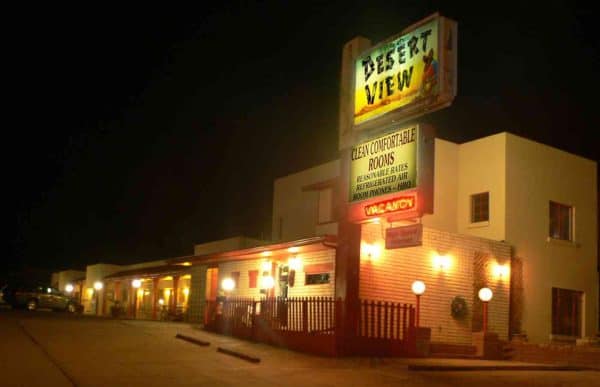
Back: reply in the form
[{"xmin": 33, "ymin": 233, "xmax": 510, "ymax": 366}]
[{"xmin": 359, "ymin": 222, "xmax": 511, "ymax": 344}]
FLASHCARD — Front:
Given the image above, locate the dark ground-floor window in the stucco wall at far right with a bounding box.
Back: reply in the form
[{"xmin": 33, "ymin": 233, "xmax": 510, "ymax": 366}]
[{"xmin": 552, "ymin": 288, "xmax": 582, "ymax": 337}]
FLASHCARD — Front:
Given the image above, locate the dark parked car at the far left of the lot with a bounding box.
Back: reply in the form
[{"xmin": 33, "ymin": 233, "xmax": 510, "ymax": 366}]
[{"xmin": 2, "ymin": 286, "xmax": 83, "ymax": 313}]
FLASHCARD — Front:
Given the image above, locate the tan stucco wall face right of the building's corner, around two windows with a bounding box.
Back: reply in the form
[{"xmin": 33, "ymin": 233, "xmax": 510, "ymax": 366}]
[{"xmin": 506, "ymin": 134, "xmax": 598, "ymax": 342}]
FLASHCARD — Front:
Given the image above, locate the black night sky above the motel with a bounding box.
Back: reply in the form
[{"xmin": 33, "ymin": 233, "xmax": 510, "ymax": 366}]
[{"xmin": 2, "ymin": 1, "xmax": 600, "ymax": 278}]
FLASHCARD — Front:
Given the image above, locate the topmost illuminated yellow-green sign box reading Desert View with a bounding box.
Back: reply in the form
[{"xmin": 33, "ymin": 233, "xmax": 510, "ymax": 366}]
[{"xmin": 353, "ymin": 14, "xmax": 456, "ymax": 126}]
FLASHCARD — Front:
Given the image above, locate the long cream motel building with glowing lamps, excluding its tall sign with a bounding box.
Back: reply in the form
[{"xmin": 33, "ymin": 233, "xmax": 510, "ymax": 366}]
[{"xmin": 55, "ymin": 132, "xmax": 598, "ymax": 355}]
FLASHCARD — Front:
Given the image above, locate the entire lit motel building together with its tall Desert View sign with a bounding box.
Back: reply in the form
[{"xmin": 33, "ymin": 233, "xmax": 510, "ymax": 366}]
[{"xmin": 55, "ymin": 14, "xmax": 599, "ymax": 358}]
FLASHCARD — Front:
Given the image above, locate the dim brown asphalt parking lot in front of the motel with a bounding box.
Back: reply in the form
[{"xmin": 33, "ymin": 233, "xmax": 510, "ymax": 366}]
[{"xmin": 0, "ymin": 308, "xmax": 600, "ymax": 387}]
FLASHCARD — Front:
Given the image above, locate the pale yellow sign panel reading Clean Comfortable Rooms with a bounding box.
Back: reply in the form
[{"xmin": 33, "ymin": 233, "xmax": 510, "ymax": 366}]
[{"xmin": 349, "ymin": 125, "xmax": 419, "ymax": 202}]
